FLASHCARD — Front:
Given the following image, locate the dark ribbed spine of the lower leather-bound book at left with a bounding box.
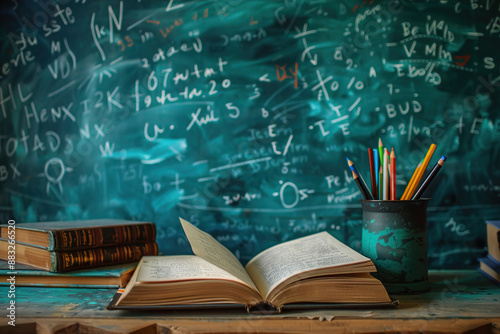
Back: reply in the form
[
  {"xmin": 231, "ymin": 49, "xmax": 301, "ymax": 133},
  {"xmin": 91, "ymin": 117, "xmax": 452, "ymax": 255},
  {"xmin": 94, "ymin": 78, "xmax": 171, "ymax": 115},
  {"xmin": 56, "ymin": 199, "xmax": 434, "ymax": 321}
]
[{"xmin": 50, "ymin": 241, "xmax": 158, "ymax": 272}]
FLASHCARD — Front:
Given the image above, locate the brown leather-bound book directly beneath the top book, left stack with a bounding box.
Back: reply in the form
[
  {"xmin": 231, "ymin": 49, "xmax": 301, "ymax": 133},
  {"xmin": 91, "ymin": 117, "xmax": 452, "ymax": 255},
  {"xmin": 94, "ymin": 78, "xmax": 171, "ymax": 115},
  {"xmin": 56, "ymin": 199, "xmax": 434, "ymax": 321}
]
[{"xmin": 0, "ymin": 240, "xmax": 158, "ymax": 272}]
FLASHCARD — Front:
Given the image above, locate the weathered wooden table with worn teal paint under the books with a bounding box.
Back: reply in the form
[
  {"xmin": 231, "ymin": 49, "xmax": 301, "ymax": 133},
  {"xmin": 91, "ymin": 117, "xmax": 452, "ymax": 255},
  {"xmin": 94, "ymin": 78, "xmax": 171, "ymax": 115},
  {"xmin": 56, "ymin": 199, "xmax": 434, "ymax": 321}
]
[{"xmin": 0, "ymin": 270, "xmax": 500, "ymax": 333}]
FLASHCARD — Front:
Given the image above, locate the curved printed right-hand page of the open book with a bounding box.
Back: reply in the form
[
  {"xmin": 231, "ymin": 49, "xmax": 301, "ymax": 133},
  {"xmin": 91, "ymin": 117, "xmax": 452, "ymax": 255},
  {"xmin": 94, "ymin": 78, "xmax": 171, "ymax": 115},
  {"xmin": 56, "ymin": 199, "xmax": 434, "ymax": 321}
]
[{"xmin": 246, "ymin": 232, "xmax": 370, "ymax": 299}]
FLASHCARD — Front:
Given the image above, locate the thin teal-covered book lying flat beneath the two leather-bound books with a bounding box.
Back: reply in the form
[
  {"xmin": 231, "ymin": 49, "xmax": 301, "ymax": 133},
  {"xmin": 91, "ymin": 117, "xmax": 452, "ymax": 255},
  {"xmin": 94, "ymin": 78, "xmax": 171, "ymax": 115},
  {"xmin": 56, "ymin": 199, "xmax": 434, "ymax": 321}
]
[{"xmin": 0, "ymin": 261, "xmax": 137, "ymax": 288}]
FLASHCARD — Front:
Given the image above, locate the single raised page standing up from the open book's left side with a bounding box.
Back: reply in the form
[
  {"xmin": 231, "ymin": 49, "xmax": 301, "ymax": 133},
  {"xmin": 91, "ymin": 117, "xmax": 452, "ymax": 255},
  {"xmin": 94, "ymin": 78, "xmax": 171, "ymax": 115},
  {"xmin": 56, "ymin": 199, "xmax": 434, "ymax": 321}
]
[{"xmin": 180, "ymin": 218, "xmax": 258, "ymax": 290}]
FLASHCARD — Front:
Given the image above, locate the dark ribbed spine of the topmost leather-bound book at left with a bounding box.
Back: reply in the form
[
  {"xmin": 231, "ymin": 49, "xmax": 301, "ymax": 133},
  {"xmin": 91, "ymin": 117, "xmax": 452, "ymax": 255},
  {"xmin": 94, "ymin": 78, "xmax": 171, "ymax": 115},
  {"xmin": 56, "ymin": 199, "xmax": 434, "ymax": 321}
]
[{"xmin": 48, "ymin": 224, "xmax": 156, "ymax": 251}]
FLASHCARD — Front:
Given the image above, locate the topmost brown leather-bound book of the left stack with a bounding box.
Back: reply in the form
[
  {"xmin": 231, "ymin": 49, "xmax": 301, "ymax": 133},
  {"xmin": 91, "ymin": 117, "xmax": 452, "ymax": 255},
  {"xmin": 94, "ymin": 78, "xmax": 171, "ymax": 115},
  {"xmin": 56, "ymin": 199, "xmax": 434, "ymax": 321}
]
[{"xmin": 0, "ymin": 219, "xmax": 156, "ymax": 251}]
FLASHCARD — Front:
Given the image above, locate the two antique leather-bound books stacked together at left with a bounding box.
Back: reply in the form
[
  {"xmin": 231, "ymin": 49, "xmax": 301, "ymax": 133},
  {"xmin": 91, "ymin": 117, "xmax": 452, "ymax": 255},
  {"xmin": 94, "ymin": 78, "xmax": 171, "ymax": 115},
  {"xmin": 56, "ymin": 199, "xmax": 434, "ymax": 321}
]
[{"xmin": 0, "ymin": 219, "xmax": 158, "ymax": 272}]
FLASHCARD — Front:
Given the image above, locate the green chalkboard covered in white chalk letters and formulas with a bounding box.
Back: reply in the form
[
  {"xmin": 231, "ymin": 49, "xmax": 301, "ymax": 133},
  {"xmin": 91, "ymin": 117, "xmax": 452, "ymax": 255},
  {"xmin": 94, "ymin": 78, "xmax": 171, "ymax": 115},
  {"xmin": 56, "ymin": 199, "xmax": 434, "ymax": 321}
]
[{"xmin": 0, "ymin": 0, "xmax": 500, "ymax": 268}]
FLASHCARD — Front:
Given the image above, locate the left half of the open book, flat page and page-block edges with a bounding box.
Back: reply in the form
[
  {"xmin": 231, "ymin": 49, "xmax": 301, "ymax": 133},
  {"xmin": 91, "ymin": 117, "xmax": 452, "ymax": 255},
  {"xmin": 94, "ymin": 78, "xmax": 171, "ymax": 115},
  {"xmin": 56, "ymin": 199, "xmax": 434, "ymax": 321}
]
[{"xmin": 116, "ymin": 255, "xmax": 262, "ymax": 306}]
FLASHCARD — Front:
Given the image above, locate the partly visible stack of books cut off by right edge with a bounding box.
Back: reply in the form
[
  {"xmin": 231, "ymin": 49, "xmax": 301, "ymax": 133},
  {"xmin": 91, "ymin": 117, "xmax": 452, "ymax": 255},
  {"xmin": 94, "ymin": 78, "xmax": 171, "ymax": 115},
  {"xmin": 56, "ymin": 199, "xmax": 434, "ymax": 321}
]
[{"xmin": 479, "ymin": 220, "xmax": 500, "ymax": 285}]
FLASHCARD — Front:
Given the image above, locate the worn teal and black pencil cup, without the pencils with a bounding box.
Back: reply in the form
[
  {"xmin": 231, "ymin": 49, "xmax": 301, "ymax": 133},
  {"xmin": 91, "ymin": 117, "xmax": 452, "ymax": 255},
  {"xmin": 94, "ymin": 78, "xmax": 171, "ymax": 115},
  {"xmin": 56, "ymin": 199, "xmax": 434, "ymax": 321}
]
[{"xmin": 361, "ymin": 199, "xmax": 430, "ymax": 294}]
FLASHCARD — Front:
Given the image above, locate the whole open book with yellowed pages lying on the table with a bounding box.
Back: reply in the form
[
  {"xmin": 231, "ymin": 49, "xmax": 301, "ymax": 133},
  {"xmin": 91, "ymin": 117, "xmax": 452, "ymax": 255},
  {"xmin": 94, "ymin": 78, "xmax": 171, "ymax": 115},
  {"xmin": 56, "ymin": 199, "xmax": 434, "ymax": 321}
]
[{"xmin": 109, "ymin": 219, "xmax": 392, "ymax": 311}]
